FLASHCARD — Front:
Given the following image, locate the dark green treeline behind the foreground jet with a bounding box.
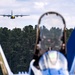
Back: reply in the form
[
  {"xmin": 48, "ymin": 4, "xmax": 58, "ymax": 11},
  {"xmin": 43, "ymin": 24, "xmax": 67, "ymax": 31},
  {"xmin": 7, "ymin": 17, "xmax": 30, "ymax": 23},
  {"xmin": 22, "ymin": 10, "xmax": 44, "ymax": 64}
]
[{"xmin": 0, "ymin": 25, "xmax": 73, "ymax": 73}]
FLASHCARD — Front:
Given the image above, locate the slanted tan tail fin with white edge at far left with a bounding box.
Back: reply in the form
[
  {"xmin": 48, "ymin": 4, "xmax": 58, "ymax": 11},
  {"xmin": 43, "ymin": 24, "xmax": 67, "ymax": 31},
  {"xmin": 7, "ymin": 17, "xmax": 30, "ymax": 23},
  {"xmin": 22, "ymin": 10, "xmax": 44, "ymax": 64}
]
[{"xmin": 0, "ymin": 45, "xmax": 13, "ymax": 75}]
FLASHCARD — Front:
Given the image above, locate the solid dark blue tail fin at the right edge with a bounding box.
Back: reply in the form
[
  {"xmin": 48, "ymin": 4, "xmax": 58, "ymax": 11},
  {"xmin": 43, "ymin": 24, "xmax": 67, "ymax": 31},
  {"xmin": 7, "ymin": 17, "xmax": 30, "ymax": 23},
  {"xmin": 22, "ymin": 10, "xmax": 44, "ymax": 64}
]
[{"xmin": 67, "ymin": 28, "xmax": 75, "ymax": 71}]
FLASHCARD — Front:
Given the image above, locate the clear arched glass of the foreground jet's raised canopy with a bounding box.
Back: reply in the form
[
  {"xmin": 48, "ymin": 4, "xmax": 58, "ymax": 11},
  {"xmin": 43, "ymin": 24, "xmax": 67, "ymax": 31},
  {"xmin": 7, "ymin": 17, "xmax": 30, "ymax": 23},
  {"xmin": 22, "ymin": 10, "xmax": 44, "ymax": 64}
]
[{"xmin": 38, "ymin": 12, "xmax": 65, "ymax": 50}]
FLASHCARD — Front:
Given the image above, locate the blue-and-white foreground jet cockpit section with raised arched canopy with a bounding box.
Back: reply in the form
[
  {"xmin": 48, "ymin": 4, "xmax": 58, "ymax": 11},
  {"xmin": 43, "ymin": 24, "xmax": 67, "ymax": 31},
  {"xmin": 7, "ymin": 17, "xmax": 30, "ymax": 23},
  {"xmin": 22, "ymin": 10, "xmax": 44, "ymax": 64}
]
[{"xmin": 30, "ymin": 11, "xmax": 69, "ymax": 75}]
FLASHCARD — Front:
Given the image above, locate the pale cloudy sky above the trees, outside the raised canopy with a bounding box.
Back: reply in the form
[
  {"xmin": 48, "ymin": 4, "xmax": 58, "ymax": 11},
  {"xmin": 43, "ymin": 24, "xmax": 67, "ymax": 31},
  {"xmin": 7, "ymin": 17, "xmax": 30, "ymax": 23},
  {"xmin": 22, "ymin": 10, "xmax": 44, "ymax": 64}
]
[{"xmin": 0, "ymin": 0, "xmax": 75, "ymax": 29}]
